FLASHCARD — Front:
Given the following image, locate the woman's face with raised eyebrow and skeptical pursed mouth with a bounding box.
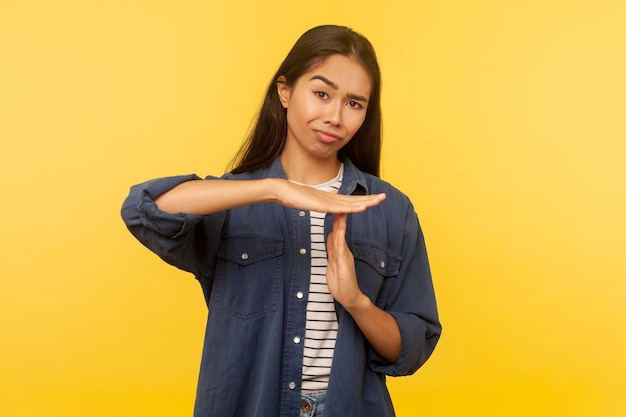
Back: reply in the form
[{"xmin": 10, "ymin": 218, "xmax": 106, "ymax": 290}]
[{"xmin": 277, "ymin": 55, "xmax": 372, "ymax": 164}]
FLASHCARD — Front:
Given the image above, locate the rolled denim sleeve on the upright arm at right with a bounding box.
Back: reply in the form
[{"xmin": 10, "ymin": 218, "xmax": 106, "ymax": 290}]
[{"xmin": 369, "ymin": 205, "xmax": 442, "ymax": 376}]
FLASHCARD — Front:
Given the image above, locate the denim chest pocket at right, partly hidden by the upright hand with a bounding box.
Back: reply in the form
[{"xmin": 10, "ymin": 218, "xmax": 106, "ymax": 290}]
[{"xmin": 352, "ymin": 241, "xmax": 401, "ymax": 308}]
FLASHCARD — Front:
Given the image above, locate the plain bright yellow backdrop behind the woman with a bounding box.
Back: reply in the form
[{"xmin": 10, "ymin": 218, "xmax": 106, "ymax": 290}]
[{"xmin": 0, "ymin": 0, "xmax": 626, "ymax": 417}]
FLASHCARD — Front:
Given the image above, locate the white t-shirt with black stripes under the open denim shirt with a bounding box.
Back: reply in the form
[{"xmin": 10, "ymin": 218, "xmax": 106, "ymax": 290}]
[{"xmin": 288, "ymin": 164, "xmax": 343, "ymax": 393}]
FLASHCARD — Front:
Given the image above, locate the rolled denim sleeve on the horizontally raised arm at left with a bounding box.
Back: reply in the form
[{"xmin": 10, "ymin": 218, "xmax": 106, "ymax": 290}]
[{"xmin": 121, "ymin": 174, "xmax": 225, "ymax": 277}]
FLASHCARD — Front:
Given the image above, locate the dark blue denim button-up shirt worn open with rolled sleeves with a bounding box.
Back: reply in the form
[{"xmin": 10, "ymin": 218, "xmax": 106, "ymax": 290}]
[{"xmin": 122, "ymin": 158, "xmax": 441, "ymax": 417}]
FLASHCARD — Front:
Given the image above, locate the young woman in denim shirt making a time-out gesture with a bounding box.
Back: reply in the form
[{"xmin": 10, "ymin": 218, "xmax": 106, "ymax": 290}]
[{"xmin": 122, "ymin": 26, "xmax": 441, "ymax": 417}]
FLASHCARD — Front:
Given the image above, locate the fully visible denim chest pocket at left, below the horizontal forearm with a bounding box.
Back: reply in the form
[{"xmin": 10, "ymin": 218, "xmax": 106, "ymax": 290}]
[{"xmin": 210, "ymin": 236, "xmax": 283, "ymax": 320}]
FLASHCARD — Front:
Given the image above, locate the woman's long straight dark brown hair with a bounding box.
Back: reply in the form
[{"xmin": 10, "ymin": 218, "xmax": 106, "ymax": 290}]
[{"xmin": 230, "ymin": 25, "xmax": 382, "ymax": 176}]
